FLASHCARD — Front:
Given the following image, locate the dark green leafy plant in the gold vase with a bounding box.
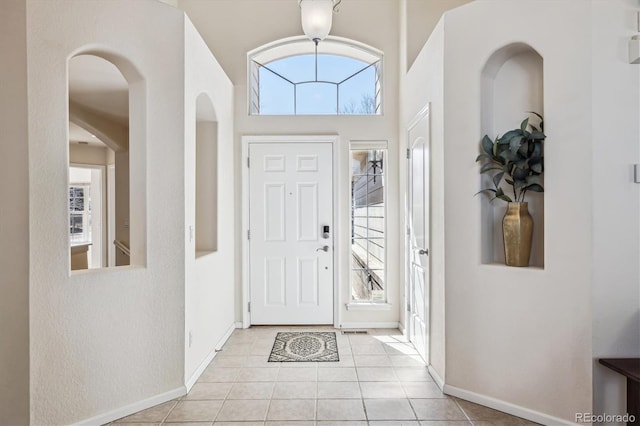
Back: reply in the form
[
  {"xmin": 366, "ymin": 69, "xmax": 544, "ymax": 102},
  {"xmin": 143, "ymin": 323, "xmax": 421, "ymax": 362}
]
[{"xmin": 476, "ymin": 112, "xmax": 546, "ymax": 202}]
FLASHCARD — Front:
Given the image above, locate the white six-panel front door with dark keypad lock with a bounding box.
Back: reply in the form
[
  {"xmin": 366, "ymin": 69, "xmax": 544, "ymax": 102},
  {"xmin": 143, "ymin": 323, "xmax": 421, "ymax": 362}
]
[{"xmin": 249, "ymin": 143, "xmax": 333, "ymax": 324}]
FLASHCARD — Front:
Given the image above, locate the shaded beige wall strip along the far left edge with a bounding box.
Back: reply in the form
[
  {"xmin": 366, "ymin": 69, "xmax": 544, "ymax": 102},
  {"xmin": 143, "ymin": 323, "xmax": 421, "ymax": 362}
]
[{"xmin": 0, "ymin": 0, "xmax": 29, "ymax": 425}]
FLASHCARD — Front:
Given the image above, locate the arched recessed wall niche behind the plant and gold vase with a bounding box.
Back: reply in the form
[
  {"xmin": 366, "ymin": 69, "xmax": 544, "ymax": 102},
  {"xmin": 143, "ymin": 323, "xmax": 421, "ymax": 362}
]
[{"xmin": 479, "ymin": 43, "xmax": 544, "ymax": 268}]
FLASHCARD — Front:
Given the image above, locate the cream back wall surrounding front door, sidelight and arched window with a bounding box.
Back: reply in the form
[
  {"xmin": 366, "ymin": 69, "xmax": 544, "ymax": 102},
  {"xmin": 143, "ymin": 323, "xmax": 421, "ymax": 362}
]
[{"xmin": 178, "ymin": 0, "xmax": 402, "ymax": 324}]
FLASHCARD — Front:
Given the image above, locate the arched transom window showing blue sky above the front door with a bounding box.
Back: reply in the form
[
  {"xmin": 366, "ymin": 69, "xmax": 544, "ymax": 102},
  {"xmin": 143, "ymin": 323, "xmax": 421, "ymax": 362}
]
[{"xmin": 248, "ymin": 36, "xmax": 382, "ymax": 115}]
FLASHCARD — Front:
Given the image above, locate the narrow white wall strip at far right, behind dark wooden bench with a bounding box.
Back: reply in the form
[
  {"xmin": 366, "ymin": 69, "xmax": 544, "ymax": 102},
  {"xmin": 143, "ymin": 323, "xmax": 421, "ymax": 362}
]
[{"xmin": 591, "ymin": 0, "xmax": 640, "ymax": 420}]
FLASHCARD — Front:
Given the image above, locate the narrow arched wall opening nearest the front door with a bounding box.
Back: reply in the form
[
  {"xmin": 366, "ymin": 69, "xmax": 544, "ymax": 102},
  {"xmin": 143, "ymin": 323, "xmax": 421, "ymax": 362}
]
[{"xmin": 195, "ymin": 93, "xmax": 218, "ymax": 257}]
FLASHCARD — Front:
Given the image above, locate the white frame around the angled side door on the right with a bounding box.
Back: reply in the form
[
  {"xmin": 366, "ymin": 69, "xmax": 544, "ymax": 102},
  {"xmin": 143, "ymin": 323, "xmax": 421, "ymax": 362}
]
[{"xmin": 404, "ymin": 102, "xmax": 431, "ymax": 365}]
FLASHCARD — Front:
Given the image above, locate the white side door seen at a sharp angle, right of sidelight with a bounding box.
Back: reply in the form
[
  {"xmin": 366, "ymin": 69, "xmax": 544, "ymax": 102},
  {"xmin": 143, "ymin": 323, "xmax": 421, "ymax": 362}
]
[{"xmin": 407, "ymin": 110, "xmax": 430, "ymax": 363}]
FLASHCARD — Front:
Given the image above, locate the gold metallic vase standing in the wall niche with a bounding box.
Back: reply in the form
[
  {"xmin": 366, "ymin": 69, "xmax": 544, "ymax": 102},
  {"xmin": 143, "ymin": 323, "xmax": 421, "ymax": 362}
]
[{"xmin": 502, "ymin": 202, "xmax": 533, "ymax": 266}]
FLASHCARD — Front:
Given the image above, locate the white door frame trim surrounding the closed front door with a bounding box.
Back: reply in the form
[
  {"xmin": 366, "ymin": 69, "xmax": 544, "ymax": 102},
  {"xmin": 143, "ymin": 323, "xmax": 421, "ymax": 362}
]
[{"xmin": 240, "ymin": 134, "xmax": 342, "ymax": 328}]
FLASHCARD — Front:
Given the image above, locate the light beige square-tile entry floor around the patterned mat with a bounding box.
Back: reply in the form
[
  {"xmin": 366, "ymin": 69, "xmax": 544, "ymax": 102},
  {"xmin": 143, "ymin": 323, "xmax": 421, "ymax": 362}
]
[{"xmin": 113, "ymin": 327, "xmax": 535, "ymax": 426}]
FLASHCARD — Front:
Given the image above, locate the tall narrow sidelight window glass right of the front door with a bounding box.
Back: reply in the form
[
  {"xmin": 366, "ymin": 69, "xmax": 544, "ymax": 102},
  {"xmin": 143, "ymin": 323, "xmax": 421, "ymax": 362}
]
[{"xmin": 351, "ymin": 150, "xmax": 386, "ymax": 302}]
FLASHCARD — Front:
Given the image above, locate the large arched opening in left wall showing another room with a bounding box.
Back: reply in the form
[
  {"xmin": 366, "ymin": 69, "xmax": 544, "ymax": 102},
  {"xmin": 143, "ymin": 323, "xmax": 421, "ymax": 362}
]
[{"xmin": 67, "ymin": 51, "xmax": 146, "ymax": 270}]
